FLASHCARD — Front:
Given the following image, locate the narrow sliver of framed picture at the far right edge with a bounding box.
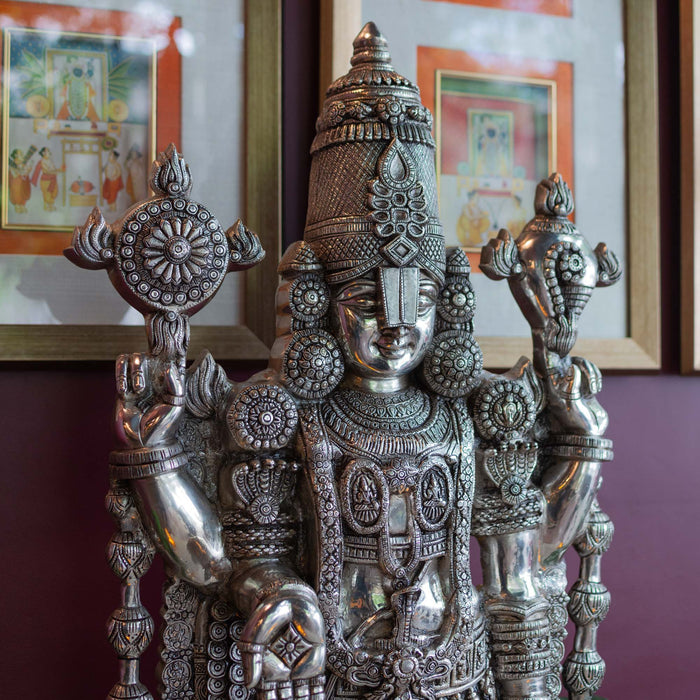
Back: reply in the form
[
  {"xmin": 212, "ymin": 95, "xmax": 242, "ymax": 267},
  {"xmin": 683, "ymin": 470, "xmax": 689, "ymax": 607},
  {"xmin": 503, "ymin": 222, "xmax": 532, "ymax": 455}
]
[{"xmin": 680, "ymin": 0, "xmax": 700, "ymax": 373}]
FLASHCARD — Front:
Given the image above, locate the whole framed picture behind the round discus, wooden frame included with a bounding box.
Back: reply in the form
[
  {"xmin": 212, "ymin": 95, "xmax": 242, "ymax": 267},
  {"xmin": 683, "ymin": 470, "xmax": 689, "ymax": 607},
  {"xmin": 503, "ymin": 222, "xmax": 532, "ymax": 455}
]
[{"xmin": 0, "ymin": 0, "xmax": 281, "ymax": 360}]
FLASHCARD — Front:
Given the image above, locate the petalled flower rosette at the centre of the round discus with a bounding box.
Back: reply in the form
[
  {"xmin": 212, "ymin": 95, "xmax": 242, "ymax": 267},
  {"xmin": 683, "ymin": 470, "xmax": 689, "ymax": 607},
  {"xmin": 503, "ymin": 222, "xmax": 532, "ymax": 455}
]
[{"xmin": 143, "ymin": 217, "xmax": 209, "ymax": 284}]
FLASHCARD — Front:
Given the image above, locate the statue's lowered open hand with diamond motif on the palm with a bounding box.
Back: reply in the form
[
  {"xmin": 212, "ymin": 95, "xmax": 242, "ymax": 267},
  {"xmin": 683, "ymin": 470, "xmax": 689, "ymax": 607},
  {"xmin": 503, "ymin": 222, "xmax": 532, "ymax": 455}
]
[{"xmin": 239, "ymin": 583, "xmax": 326, "ymax": 697}]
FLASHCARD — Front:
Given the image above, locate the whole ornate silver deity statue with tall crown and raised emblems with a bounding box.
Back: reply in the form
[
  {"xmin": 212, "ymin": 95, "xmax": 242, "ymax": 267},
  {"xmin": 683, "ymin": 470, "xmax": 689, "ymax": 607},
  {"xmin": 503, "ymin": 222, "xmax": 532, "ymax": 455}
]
[{"xmin": 67, "ymin": 23, "xmax": 620, "ymax": 700}]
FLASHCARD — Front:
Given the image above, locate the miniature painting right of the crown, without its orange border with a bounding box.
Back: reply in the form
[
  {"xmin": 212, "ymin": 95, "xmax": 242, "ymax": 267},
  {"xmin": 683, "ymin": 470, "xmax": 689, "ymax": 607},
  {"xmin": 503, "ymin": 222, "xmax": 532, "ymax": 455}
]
[{"xmin": 438, "ymin": 74, "xmax": 553, "ymax": 252}]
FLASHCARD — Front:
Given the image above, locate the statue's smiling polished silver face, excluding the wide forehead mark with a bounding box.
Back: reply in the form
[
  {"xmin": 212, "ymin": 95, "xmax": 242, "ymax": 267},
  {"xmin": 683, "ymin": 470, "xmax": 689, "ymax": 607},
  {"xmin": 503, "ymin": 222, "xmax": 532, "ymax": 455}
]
[{"xmin": 332, "ymin": 273, "xmax": 439, "ymax": 379}]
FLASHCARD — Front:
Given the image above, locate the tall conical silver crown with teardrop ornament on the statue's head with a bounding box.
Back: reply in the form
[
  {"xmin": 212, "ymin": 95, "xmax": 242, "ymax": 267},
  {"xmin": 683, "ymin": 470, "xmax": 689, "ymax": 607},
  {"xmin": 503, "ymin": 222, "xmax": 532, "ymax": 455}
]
[{"xmin": 304, "ymin": 22, "xmax": 445, "ymax": 283}]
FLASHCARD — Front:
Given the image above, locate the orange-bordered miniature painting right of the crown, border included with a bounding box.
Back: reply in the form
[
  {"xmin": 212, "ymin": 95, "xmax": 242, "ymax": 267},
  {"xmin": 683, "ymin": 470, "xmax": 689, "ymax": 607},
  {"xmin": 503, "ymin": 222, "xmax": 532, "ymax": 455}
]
[{"xmin": 417, "ymin": 46, "xmax": 574, "ymax": 271}]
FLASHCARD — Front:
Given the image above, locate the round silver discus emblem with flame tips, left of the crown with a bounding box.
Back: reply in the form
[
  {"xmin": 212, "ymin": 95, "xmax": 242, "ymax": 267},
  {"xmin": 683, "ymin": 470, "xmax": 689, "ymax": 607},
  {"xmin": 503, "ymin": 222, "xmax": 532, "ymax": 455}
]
[{"xmin": 64, "ymin": 144, "xmax": 265, "ymax": 361}]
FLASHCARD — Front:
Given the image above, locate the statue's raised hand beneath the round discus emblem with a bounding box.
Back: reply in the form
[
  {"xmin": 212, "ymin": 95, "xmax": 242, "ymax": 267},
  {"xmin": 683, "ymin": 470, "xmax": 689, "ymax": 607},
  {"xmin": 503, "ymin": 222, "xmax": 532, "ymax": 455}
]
[{"xmin": 114, "ymin": 353, "xmax": 185, "ymax": 449}]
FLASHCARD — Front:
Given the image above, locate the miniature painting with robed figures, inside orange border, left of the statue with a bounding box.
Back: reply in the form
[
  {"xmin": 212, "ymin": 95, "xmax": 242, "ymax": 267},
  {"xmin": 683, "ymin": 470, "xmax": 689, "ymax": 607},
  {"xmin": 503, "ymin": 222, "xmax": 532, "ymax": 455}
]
[{"xmin": 2, "ymin": 28, "xmax": 155, "ymax": 235}]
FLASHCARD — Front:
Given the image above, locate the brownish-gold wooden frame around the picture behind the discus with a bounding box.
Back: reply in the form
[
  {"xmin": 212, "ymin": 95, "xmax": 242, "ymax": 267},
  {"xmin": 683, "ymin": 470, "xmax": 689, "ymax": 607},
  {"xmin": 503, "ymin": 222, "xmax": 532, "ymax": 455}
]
[{"xmin": 0, "ymin": 0, "xmax": 282, "ymax": 361}]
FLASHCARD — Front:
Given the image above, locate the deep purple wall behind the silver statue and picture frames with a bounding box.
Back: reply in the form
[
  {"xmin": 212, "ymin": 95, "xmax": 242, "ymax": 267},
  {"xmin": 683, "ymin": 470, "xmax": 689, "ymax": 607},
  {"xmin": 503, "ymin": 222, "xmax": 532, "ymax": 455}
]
[{"xmin": 0, "ymin": 0, "xmax": 700, "ymax": 700}]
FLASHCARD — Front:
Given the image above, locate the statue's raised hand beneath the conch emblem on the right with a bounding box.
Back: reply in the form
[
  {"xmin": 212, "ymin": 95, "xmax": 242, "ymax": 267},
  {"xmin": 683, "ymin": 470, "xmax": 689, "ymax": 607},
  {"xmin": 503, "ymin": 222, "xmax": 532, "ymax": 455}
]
[{"xmin": 543, "ymin": 353, "xmax": 608, "ymax": 437}]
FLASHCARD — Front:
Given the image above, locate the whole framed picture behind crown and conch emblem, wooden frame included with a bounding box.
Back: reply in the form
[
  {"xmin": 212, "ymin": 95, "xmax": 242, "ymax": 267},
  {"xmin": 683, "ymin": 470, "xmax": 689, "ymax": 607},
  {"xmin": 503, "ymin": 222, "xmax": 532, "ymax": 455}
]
[{"xmin": 321, "ymin": 0, "xmax": 660, "ymax": 369}]
